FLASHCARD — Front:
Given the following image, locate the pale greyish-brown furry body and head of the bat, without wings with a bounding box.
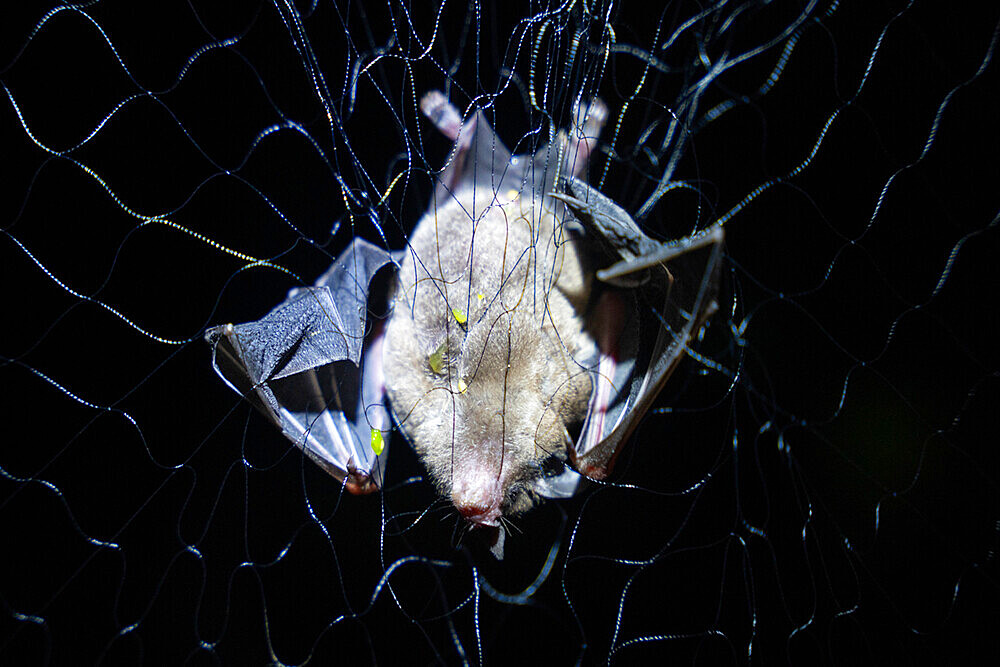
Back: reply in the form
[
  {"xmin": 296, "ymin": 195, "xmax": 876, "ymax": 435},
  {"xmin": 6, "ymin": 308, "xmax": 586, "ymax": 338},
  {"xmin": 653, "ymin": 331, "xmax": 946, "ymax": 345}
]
[{"xmin": 383, "ymin": 189, "xmax": 595, "ymax": 514}]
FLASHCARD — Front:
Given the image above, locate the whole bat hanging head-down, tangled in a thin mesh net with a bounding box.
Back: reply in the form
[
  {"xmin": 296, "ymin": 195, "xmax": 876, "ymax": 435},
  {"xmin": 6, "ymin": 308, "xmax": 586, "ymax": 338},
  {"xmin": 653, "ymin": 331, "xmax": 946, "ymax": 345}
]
[{"xmin": 206, "ymin": 91, "xmax": 724, "ymax": 557}]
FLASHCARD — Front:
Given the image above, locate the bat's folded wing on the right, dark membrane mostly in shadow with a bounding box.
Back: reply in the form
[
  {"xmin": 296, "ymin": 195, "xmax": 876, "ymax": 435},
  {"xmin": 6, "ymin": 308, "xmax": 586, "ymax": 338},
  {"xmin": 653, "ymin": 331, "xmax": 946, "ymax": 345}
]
[{"xmin": 551, "ymin": 179, "xmax": 723, "ymax": 479}]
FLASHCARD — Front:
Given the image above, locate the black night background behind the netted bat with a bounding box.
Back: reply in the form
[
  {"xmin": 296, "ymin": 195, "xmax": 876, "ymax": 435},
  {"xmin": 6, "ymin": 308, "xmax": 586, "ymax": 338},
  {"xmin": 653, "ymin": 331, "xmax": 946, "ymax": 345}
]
[{"xmin": 0, "ymin": 2, "xmax": 1000, "ymax": 664}]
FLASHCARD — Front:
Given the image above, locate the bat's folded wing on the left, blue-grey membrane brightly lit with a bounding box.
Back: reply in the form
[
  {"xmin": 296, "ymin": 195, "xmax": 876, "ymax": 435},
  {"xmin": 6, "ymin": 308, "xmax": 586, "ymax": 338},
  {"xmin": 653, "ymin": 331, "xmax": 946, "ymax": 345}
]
[{"xmin": 205, "ymin": 239, "xmax": 395, "ymax": 493}]
